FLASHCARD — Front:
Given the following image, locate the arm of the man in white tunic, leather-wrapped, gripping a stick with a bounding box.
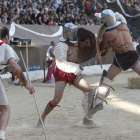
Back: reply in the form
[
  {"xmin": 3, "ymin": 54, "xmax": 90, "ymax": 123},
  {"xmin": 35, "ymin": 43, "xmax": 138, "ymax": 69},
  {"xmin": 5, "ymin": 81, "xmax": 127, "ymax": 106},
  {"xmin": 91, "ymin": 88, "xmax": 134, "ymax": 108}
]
[{"xmin": 8, "ymin": 58, "xmax": 35, "ymax": 94}]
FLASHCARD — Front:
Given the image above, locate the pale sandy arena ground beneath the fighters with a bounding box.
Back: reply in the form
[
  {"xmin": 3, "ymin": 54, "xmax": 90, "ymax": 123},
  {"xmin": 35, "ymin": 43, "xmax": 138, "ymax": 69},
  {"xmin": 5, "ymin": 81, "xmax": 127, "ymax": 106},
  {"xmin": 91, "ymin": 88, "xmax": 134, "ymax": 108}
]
[{"xmin": 6, "ymin": 72, "xmax": 140, "ymax": 140}]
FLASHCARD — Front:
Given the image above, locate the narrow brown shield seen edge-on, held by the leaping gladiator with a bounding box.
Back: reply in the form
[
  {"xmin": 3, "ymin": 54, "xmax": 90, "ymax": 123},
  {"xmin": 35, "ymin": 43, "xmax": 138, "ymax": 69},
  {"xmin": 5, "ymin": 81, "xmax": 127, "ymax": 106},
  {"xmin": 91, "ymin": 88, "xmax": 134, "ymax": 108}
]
[{"xmin": 96, "ymin": 25, "xmax": 106, "ymax": 68}]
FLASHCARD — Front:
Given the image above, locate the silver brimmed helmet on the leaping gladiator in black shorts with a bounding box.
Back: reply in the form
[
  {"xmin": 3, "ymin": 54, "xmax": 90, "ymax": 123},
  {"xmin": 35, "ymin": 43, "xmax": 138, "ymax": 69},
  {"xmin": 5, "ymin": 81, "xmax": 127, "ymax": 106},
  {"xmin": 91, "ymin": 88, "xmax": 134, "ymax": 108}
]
[{"xmin": 101, "ymin": 9, "xmax": 121, "ymax": 30}]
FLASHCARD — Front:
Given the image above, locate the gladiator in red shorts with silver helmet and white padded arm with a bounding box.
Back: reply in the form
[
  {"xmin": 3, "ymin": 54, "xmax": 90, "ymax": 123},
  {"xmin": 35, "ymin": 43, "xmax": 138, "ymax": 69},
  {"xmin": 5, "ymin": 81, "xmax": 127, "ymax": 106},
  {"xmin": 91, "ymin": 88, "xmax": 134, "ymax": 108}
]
[{"xmin": 37, "ymin": 23, "xmax": 99, "ymax": 127}]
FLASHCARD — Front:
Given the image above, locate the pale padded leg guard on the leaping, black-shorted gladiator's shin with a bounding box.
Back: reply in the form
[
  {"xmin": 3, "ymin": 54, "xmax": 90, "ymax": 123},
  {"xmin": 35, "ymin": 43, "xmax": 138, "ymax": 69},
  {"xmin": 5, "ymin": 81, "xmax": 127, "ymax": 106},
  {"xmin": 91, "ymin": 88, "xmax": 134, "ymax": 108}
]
[{"xmin": 96, "ymin": 70, "xmax": 114, "ymax": 104}]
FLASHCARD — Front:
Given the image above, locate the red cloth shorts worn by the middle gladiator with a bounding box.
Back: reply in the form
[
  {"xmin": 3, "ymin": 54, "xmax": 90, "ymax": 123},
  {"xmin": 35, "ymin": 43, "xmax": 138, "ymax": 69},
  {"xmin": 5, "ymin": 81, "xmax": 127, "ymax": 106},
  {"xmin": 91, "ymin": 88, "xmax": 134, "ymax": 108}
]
[{"xmin": 54, "ymin": 67, "xmax": 76, "ymax": 83}]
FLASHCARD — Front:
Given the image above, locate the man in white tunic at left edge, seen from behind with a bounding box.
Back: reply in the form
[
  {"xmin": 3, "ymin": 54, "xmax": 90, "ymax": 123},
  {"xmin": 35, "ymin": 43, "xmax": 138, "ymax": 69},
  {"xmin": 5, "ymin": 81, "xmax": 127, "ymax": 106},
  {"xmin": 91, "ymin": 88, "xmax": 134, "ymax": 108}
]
[{"xmin": 0, "ymin": 27, "xmax": 35, "ymax": 140}]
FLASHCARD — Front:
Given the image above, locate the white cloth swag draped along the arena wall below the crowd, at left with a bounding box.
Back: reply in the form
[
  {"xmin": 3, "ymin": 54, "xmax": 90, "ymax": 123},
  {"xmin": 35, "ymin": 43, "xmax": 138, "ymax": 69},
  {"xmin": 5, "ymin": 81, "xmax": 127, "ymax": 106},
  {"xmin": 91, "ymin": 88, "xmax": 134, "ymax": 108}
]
[{"xmin": 9, "ymin": 22, "xmax": 63, "ymax": 37}]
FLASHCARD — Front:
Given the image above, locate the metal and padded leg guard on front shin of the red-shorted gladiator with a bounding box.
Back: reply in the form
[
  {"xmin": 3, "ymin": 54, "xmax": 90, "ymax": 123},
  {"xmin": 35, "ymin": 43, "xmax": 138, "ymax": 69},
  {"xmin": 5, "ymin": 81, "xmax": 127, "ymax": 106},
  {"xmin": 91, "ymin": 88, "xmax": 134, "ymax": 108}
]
[{"xmin": 82, "ymin": 89, "xmax": 103, "ymax": 120}]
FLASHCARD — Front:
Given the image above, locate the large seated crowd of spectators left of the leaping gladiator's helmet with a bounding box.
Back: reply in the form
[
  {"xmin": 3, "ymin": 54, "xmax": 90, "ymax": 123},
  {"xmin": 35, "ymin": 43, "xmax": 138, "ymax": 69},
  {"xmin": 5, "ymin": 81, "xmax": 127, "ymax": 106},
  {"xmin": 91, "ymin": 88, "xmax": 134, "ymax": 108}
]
[{"xmin": 0, "ymin": 0, "xmax": 108, "ymax": 25}]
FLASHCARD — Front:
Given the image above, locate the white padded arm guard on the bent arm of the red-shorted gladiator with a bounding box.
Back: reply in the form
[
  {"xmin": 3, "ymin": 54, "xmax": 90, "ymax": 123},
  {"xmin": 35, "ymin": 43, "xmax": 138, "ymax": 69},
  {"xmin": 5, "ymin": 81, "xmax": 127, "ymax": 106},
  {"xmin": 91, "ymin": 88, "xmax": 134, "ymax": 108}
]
[{"xmin": 55, "ymin": 42, "xmax": 82, "ymax": 75}]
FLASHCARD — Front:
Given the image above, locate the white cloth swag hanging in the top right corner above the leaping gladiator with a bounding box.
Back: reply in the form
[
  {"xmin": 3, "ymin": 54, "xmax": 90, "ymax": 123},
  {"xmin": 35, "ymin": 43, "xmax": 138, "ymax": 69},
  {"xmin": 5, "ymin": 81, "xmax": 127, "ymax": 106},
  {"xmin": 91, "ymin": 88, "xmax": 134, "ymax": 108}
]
[{"xmin": 106, "ymin": 0, "xmax": 140, "ymax": 18}]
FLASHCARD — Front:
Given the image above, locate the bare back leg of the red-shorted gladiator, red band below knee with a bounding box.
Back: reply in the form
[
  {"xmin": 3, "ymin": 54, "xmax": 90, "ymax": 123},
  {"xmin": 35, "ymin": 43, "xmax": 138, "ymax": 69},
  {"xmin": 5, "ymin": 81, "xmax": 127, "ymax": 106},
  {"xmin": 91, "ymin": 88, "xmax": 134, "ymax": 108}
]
[{"xmin": 37, "ymin": 81, "xmax": 66, "ymax": 127}]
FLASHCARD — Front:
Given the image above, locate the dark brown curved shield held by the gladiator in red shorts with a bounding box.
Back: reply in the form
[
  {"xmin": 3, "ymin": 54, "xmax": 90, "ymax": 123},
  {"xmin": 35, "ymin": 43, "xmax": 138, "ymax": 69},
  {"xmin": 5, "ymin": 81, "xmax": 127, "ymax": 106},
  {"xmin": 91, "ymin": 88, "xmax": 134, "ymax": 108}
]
[{"xmin": 77, "ymin": 28, "xmax": 97, "ymax": 63}]
